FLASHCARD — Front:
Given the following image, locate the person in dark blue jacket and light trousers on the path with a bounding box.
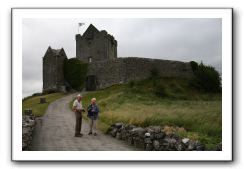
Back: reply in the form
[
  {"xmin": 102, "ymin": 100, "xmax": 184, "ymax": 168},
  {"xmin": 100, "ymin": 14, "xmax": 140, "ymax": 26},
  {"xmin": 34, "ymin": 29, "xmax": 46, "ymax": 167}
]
[{"xmin": 87, "ymin": 98, "xmax": 99, "ymax": 136}]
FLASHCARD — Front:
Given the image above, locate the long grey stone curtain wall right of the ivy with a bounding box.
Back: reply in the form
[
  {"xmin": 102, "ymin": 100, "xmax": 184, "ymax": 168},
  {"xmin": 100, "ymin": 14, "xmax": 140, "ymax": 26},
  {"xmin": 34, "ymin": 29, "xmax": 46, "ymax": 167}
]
[{"xmin": 87, "ymin": 57, "xmax": 193, "ymax": 89}]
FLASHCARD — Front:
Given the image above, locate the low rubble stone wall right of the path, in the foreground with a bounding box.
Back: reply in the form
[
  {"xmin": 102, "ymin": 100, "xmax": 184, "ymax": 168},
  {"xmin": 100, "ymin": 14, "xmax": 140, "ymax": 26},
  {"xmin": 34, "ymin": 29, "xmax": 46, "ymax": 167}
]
[{"xmin": 108, "ymin": 123, "xmax": 205, "ymax": 151}]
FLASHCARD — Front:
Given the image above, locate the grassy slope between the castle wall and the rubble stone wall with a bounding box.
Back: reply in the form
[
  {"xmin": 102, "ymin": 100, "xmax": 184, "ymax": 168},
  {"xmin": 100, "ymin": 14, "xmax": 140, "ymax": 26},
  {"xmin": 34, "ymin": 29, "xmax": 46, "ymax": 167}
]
[{"xmin": 82, "ymin": 79, "xmax": 222, "ymax": 150}]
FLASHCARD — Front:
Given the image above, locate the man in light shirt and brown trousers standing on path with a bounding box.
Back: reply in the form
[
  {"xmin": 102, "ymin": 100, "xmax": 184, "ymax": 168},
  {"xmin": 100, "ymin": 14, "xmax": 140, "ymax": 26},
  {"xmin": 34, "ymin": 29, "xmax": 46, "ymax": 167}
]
[{"xmin": 73, "ymin": 94, "xmax": 84, "ymax": 137}]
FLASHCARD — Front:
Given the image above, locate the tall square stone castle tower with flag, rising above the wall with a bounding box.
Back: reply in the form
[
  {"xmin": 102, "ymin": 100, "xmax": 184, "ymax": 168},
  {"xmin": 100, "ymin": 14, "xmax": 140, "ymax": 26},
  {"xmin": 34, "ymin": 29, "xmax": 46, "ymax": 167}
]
[{"xmin": 76, "ymin": 24, "xmax": 117, "ymax": 62}]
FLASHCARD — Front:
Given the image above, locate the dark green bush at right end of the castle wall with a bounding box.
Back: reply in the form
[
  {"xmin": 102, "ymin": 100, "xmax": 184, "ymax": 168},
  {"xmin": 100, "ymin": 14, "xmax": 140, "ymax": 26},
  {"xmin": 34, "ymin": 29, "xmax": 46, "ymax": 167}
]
[{"xmin": 190, "ymin": 62, "xmax": 221, "ymax": 92}]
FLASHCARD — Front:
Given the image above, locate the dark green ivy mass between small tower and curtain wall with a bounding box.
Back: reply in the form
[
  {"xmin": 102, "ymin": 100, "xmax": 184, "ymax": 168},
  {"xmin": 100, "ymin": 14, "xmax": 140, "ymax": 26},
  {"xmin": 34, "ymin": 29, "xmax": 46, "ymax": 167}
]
[{"xmin": 64, "ymin": 58, "xmax": 88, "ymax": 90}]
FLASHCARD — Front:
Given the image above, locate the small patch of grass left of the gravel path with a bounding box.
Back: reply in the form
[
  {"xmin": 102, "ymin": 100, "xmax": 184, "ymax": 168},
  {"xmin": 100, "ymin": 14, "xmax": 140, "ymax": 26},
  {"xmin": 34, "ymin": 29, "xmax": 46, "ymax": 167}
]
[{"xmin": 22, "ymin": 93, "xmax": 64, "ymax": 116}]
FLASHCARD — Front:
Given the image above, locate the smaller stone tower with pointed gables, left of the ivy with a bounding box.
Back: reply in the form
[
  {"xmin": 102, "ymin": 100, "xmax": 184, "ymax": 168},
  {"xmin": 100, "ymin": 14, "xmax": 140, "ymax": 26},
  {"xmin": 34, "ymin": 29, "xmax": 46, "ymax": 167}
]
[{"xmin": 42, "ymin": 46, "xmax": 67, "ymax": 93}]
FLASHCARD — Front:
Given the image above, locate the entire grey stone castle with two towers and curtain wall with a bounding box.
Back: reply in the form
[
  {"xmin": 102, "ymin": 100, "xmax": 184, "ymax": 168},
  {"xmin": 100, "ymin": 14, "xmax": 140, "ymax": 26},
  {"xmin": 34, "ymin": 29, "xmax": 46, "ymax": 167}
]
[{"xmin": 43, "ymin": 24, "xmax": 193, "ymax": 92}]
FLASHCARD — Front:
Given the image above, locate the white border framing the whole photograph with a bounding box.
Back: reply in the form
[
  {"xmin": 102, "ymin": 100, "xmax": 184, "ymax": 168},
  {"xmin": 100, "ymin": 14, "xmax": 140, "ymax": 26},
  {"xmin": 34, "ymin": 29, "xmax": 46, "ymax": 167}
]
[{"xmin": 12, "ymin": 8, "xmax": 232, "ymax": 161}]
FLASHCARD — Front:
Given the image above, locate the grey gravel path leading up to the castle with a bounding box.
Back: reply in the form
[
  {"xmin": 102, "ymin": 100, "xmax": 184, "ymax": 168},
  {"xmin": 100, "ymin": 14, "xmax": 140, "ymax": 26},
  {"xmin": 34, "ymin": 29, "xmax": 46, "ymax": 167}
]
[{"xmin": 31, "ymin": 94, "xmax": 135, "ymax": 151}]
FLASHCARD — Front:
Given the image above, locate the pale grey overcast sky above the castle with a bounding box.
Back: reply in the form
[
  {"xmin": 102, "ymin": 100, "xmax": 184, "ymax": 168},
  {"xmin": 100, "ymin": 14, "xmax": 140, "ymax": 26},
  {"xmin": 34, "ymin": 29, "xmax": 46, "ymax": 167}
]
[{"xmin": 22, "ymin": 19, "xmax": 222, "ymax": 97}]
